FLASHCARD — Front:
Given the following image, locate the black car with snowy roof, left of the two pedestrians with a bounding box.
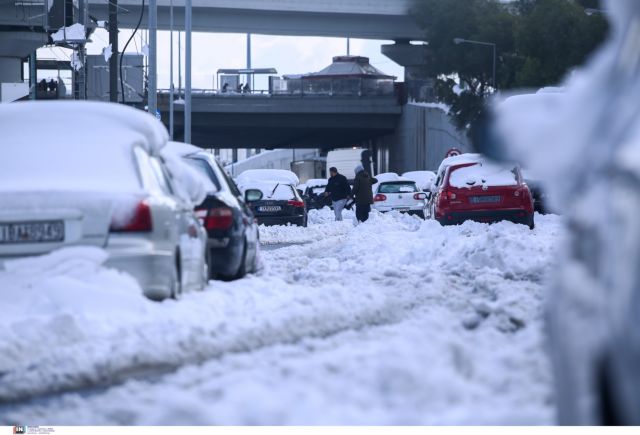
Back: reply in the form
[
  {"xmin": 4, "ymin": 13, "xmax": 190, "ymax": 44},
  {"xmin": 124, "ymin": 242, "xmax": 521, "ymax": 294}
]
[{"xmin": 243, "ymin": 181, "xmax": 307, "ymax": 227}]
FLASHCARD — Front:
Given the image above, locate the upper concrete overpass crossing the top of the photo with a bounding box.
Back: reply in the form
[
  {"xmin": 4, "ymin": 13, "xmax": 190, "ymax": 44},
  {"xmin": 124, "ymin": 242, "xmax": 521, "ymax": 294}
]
[{"xmin": 90, "ymin": 0, "xmax": 423, "ymax": 40}]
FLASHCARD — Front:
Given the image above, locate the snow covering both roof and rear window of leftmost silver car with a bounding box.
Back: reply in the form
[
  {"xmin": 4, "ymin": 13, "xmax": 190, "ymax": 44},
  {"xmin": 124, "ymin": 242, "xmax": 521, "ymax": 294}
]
[{"xmin": 0, "ymin": 101, "xmax": 168, "ymax": 193}]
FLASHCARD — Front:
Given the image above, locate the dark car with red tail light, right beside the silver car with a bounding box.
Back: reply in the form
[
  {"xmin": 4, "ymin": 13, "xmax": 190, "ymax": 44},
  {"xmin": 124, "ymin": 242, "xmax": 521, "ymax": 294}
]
[{"xmin": 167, "ymin": 142, "xmax": 260, "ymax": 280}]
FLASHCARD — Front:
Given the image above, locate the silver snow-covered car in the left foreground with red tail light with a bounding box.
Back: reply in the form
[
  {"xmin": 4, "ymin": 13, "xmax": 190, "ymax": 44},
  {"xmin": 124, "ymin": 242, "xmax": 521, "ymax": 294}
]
[{"xmin": 0, "ymin": 102, "xmax": 207, "ymax": 300}]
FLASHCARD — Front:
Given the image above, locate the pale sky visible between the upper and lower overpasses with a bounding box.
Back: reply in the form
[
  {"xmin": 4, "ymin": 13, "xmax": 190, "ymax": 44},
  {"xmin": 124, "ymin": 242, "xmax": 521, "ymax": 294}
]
[{"xmin": 38, "ymin": 29, "xmax": 404, "ymax": 89}]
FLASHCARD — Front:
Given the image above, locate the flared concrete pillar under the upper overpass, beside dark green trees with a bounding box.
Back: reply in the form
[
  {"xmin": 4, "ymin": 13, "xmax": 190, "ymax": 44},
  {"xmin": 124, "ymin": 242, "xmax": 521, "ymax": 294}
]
[{"xmin": 381, "ymin": 40, "xmax": 435, "ymax": 102}]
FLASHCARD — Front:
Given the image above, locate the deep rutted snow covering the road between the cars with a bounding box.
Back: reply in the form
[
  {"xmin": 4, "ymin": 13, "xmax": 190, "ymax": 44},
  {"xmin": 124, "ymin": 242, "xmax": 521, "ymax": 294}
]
[{"xmin": 0, "ymin": 210, "xmax": 563, "ymax": 425}]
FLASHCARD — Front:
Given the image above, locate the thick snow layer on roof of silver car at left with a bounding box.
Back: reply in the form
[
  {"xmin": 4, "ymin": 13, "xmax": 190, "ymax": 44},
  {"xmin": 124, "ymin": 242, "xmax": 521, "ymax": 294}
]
[{"xmin": 0, "ymin": 101, "xmax": 169, "ymax": 154}]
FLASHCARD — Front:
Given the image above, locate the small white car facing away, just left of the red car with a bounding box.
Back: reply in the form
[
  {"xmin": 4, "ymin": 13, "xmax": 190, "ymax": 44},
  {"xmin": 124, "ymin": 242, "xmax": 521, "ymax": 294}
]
[{"xmin": 372, "ymin": 173, "xmax": 427, "ymax": 219}]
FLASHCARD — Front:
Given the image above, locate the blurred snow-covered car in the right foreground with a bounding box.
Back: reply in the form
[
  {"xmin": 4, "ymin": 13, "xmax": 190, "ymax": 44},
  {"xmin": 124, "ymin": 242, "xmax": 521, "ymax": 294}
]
[{"xmin": 492, "ymin": 0, "xmax": 640, "ymax": 426}]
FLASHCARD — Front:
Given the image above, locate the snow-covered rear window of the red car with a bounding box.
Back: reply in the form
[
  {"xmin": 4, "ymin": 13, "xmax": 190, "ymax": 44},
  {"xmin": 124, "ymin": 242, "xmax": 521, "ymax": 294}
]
[{"xmin": 449, "ymin": 162, "xmax": 518, "ymax": 188}]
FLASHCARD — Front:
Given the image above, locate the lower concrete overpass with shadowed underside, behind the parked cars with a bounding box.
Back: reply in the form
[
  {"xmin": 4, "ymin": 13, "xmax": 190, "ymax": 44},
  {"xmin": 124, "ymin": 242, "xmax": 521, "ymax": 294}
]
[{"xmin": 158, "ymin": 93, "xmax": 402, "ymax": 148}]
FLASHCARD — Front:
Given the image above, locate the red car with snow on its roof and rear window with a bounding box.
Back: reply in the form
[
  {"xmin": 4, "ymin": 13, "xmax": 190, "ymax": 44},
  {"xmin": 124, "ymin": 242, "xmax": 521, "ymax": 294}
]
[{"xmin": 429, "ymin": 154, "xmax": 535, "ymax": 229}]
